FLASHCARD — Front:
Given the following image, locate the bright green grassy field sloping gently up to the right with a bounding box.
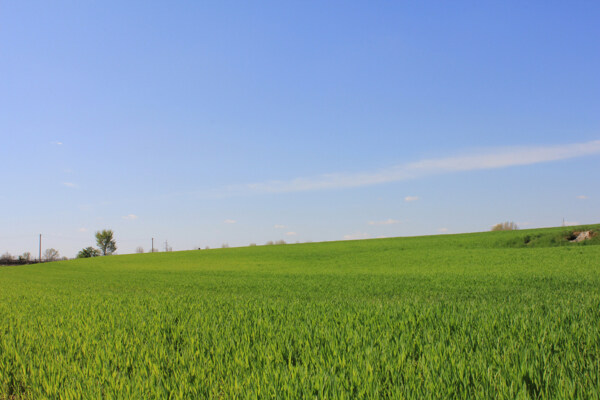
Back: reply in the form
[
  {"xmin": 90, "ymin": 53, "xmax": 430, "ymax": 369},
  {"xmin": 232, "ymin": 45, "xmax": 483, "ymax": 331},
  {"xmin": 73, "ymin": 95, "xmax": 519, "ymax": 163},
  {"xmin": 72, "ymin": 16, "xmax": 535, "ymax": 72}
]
[{"xmin": 0, "ymin": 225, "xmax": 600, "ymax": 399}]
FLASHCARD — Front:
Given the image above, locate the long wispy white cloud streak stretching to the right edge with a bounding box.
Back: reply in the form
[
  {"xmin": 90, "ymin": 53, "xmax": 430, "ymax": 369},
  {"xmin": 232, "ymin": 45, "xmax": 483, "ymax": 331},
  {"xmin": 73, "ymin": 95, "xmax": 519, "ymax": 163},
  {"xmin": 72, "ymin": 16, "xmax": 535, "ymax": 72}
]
[{"xmin": 226, "ymin": 140, "xmax": 600, "ymax": 195}]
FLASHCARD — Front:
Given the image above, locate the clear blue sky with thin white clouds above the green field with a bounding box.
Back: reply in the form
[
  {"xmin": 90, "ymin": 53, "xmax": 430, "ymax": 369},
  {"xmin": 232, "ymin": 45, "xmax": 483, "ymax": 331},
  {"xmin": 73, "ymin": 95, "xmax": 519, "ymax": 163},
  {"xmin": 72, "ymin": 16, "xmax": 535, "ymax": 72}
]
[{"xmin": 0, "ymin": 1, "xmax": 600, "ymax": 257}]
